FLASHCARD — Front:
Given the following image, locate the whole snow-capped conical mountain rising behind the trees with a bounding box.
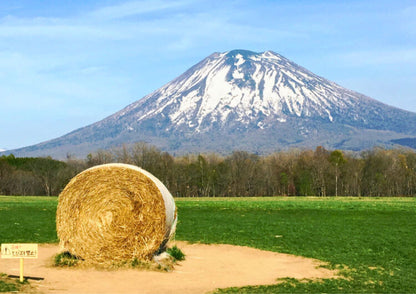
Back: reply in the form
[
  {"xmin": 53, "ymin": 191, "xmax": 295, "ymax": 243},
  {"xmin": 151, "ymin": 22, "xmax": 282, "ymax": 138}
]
[{"xmin": 4, "ymin": 50, "xmax": 416, "ymax": 156}]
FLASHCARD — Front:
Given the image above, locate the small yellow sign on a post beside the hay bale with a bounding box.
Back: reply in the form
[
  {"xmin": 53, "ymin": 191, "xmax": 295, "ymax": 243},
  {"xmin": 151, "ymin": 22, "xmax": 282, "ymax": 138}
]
[{"xmin": 1, "ymin": 243, "xmax": 38, "ymax": 282}]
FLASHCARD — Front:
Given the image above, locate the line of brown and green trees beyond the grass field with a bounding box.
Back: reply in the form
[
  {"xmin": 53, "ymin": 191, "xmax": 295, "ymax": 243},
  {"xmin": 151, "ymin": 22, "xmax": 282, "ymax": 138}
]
[{"xmin": 0, "ymin": 143, "xmax": 416, "ymax": 197}]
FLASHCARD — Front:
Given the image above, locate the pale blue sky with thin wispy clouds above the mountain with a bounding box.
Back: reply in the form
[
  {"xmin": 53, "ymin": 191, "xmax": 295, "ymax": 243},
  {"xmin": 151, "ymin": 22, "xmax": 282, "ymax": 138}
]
[{"xmin": 0, "ymin": 0, "xmax": 416, "ymax": 149}]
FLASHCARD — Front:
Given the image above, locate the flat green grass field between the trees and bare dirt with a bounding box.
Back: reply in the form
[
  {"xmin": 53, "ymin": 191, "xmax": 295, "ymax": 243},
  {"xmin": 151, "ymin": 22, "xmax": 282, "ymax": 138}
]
[{"xmin": 0, "ymin": 196, "xmax": 416, "ymax": 293}]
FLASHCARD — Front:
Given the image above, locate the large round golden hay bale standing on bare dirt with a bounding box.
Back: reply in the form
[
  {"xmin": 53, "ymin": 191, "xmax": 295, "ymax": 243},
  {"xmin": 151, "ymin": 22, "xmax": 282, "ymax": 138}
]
[{"xmin": 56, "ymin": 163, "xmax": 177, "ymax": 263}]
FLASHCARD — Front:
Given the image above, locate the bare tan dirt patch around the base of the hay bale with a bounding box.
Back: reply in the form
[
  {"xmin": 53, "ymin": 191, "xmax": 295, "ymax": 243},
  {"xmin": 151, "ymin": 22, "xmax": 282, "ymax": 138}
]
[{"xmin": 0, "ymin": 242, "xmax": 336, "ymax": 294}]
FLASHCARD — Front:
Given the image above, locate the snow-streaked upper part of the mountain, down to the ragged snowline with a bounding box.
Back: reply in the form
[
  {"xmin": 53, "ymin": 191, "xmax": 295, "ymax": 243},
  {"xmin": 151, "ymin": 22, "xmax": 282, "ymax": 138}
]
[{"xmin": 110, "ymin": 50, "xmax": 386, "ymax": 132}]
